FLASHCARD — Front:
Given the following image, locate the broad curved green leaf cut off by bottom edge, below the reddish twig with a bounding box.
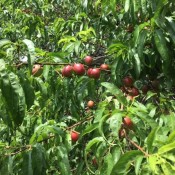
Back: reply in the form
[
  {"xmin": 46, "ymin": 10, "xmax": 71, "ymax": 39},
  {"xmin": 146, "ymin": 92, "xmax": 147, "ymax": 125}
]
[{"xmin": 111, "ymin": 150, "xmax": 143, "ymax": 175}]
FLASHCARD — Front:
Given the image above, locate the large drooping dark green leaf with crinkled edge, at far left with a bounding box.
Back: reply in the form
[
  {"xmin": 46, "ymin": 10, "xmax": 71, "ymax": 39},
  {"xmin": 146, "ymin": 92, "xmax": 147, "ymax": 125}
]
[{"xmin": 0, "ymin": 60, "xmax": 26, "ymax": 126}]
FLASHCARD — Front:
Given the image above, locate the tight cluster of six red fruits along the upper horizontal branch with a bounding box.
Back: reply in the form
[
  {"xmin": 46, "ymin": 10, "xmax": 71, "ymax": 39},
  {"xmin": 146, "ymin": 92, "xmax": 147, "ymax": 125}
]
[{"xmin": 62, "ymin": 56, "xmax": 109, "ymax": 79}]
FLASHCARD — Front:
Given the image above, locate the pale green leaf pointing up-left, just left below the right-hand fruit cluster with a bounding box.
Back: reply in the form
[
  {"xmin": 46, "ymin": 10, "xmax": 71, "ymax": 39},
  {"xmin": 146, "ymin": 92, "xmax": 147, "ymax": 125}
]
[{"xmin": 101, "ymin": 82, "xmax": 127, "ymax": 106}]
